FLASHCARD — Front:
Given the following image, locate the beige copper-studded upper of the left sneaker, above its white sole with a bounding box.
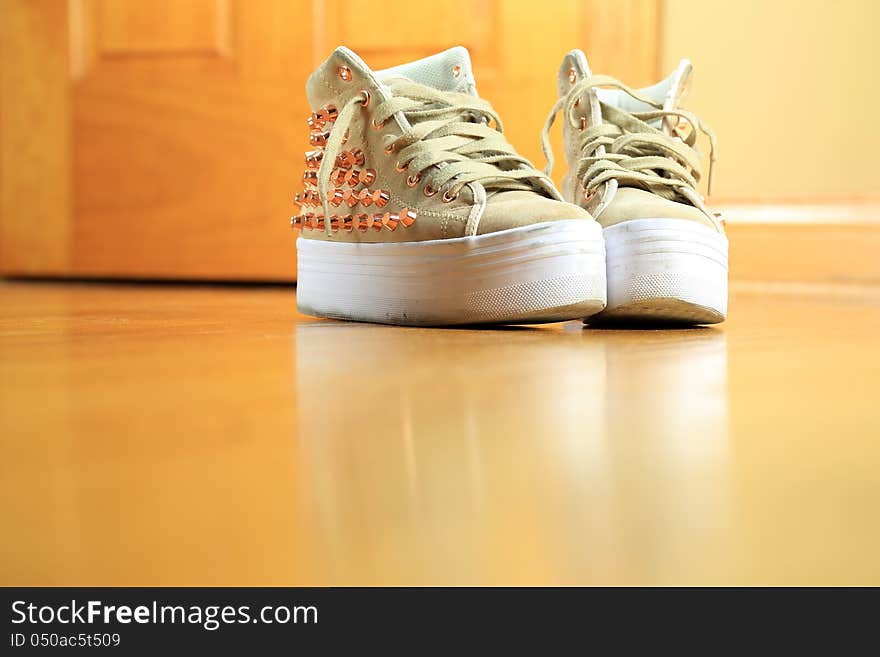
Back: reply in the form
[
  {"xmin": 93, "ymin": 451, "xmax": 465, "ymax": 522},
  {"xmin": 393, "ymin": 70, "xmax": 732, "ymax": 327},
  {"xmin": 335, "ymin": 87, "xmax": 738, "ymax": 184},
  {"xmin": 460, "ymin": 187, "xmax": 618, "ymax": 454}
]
[{"xmin": 292, "ymin": 47, "xmax": 591, "ymax": 242}]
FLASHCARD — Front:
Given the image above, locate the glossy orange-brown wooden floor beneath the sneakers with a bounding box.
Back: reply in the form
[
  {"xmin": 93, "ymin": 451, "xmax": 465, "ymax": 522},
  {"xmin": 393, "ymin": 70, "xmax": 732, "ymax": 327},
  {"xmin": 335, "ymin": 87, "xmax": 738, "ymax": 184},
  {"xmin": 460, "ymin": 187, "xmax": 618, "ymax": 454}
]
[{"xmin": 0, "ymin": 283, "xmax": 880, "ymax": 585}]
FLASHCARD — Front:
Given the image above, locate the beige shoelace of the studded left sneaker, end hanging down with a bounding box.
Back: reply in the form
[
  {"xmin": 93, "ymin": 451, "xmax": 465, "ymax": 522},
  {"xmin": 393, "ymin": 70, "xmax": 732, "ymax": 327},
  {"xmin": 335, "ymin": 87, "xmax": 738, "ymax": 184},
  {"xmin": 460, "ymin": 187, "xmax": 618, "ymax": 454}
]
[{"xmin": 317, "ymin": 79, "xmax": 552, "ymax": 231}]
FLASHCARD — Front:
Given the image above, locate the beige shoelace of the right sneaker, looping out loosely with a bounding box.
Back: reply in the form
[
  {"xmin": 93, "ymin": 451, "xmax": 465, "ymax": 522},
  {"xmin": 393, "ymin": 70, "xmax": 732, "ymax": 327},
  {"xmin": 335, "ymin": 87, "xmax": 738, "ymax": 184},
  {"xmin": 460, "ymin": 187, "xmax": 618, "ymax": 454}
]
[{"xmin": 541, "ymin": 75, "xmax": 716, "ymax": 201}]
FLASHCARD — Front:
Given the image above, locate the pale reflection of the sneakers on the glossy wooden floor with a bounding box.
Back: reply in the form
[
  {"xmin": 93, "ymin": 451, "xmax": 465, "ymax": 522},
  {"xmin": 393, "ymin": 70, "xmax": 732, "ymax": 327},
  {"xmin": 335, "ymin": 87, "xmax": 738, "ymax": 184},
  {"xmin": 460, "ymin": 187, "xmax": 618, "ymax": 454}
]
[{"xmin": 296, "ymin": 322, "xmax": 729, "ymax": 583}]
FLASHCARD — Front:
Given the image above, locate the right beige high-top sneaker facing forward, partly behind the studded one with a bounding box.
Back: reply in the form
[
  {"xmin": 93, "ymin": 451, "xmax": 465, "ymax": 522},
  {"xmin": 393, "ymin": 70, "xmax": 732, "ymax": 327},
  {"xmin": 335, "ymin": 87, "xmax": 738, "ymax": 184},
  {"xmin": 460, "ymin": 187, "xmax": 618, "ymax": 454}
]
[{"xmin": 542, "ymin": 50, "xmax": 727, "ymax": 324}]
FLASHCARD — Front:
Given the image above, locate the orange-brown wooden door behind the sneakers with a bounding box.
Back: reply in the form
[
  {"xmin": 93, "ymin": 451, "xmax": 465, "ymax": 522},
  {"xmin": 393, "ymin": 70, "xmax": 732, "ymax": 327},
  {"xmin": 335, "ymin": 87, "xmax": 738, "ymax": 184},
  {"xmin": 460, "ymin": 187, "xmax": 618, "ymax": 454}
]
[{"xmin": 0, "ymin": 0, "xmax": 657, "ymax": 280}]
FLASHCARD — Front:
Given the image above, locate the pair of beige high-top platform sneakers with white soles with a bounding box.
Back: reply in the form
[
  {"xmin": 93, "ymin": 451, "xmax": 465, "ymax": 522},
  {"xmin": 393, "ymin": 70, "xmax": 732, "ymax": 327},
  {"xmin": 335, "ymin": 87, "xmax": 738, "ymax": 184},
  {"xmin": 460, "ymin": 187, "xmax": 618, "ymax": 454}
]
[{"xmin": 291, "ymin": 47, "xmax": 727, "ymax": 325}]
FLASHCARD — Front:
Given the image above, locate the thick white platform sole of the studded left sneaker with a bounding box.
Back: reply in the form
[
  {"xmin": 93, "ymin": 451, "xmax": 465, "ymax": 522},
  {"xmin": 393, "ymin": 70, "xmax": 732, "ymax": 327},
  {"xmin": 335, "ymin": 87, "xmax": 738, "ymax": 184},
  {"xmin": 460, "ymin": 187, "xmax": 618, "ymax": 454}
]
[{"xmin": 296, "ymin": 219, "xmax": 605, "ymax": 326}]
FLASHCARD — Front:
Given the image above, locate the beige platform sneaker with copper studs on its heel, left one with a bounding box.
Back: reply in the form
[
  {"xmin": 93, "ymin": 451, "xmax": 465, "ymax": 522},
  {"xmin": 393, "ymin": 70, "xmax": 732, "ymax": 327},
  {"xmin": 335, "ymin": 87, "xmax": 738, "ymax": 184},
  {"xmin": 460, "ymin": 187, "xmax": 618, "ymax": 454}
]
[{"xmin": 291, "ymin": 47, "xmax": 605, "ymax": 325}]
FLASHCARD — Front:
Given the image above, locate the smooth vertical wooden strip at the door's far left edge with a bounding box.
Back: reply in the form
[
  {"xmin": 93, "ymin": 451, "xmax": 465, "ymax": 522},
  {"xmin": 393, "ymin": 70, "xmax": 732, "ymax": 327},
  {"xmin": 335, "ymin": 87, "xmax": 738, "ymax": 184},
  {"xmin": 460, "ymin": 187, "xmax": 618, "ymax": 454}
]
[{"xmin": 0, "ymin": 0, "xmax": 70, "ymax": 275}]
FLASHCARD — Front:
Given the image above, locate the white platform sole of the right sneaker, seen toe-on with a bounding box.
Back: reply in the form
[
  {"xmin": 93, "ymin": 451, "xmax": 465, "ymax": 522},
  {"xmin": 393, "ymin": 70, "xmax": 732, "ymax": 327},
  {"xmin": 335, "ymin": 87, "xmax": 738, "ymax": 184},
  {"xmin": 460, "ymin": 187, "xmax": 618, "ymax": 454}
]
[{"xmin": 590, "ymin": 219, "xmax": 728, "ymax": 324}]
